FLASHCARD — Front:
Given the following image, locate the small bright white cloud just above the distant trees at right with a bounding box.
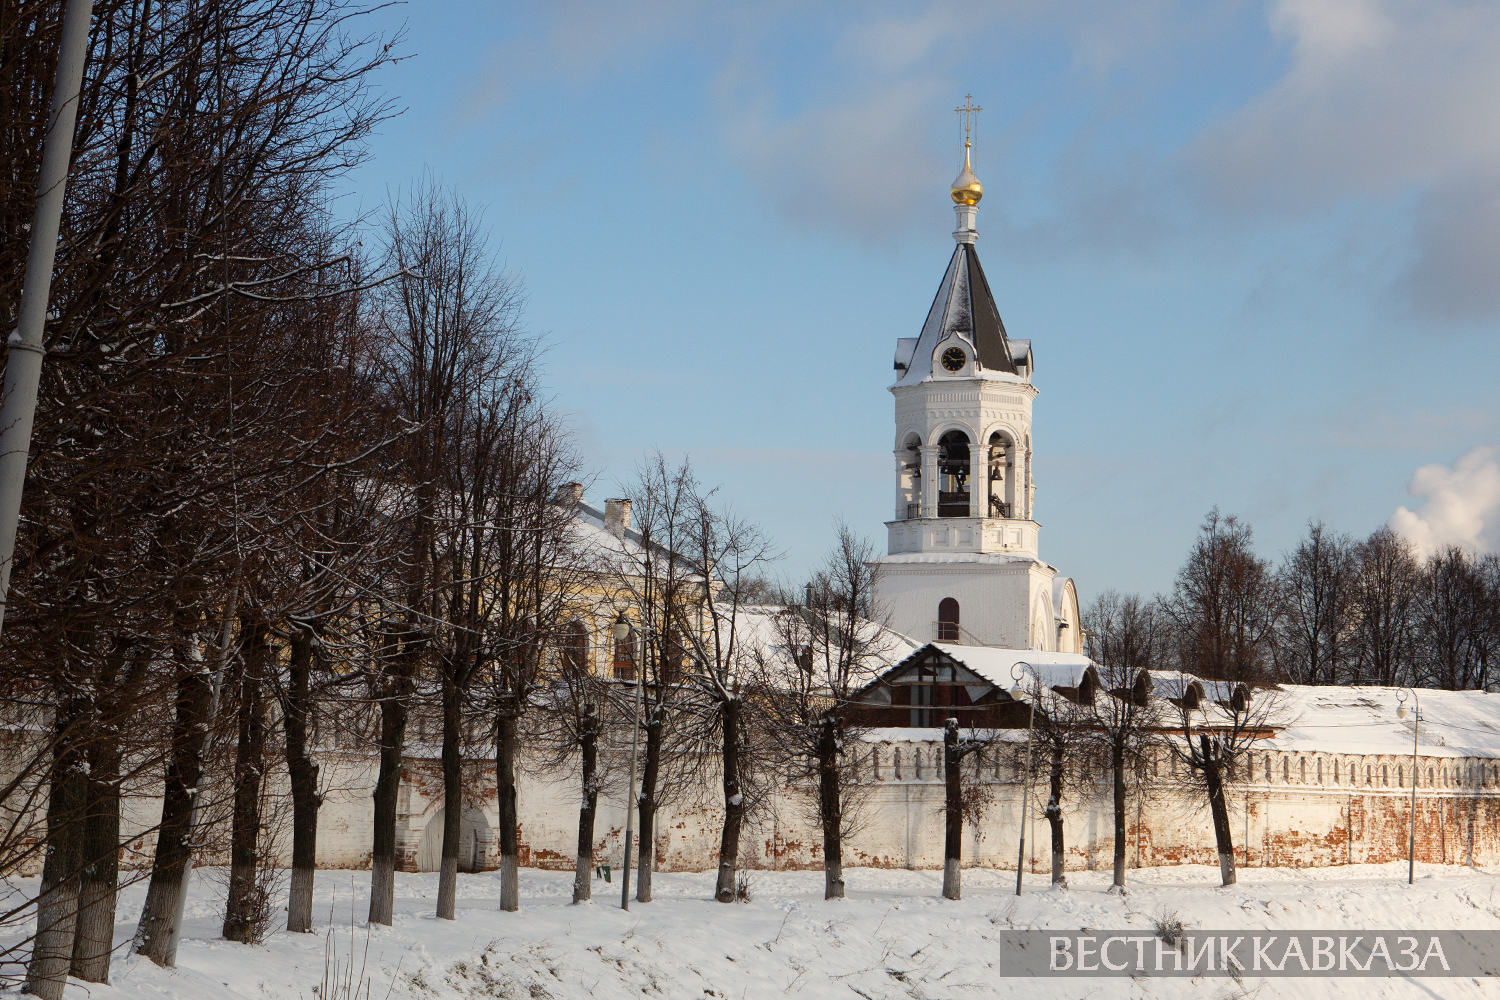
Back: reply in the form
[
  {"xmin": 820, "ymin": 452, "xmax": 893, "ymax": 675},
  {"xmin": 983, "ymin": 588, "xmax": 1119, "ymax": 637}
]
[{"xmin": 1388, "ymin": 447, "xmax": 1500, "ymax": 556}]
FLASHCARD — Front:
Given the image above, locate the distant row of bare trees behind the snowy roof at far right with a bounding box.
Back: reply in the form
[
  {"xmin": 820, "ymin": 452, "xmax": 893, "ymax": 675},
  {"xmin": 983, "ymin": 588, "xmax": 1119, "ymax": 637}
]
[{"xmin": 1143, "ymin": 510, "xmax": 1500, "ymax": 690}]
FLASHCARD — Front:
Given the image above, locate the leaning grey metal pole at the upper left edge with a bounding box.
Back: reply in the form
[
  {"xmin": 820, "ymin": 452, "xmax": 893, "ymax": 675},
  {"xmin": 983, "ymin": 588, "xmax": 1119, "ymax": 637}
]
[{"xmin": 0, "ymin": 0, "xmax": 93, "ymax": 641}]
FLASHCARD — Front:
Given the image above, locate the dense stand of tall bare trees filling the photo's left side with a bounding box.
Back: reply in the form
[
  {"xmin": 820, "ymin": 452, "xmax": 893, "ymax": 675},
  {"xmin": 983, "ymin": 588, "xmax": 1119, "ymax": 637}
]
[{"xmin": 0, "ymin": 0, "xmax": 615, "ymax": 997}]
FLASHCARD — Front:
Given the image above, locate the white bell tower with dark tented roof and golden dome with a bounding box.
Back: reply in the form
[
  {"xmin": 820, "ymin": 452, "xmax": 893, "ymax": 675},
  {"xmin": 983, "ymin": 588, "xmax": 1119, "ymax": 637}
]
[{"xmin": 875, "ymin": 121, "xmax": 1082, "ymax": 652}]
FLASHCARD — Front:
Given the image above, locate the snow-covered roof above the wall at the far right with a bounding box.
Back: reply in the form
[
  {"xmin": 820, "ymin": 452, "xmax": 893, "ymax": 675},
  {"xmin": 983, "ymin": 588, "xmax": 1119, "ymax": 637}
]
[{"xmin": 1257, "ymin": 684, "xmax": 1500, "ymax": 757}]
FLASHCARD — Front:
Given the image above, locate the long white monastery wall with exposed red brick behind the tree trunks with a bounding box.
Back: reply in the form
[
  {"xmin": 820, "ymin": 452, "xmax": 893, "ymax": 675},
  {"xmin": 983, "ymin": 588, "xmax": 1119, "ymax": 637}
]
[{"xmin": 27, "ymin": 741, "xmax": 1500, "ymax": 874}]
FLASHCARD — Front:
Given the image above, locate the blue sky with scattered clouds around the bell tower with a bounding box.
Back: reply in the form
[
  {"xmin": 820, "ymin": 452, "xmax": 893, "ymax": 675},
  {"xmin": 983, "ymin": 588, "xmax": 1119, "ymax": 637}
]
[{"xmin": 341, "ymin": 0, "xmax": 1500, "ymax": 600}]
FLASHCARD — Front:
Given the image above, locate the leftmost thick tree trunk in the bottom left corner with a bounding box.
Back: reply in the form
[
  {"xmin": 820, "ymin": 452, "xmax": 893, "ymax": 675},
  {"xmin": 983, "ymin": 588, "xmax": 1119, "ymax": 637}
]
[{"xmin": 24, "ymin": 709, "xmax": 89, "ymax": 1000}]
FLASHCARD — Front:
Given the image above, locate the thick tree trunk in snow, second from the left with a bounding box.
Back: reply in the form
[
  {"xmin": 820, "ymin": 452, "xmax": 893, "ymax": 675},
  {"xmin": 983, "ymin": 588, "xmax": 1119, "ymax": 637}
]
[{"xmin": 72, "ymin": 743, "xmax": 120, "ymax": 984}]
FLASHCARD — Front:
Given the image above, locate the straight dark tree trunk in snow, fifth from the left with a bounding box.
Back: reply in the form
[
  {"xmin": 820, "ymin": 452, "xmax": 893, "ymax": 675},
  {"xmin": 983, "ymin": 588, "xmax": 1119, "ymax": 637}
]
[{"xmin": 282, "ymin": 630, "xmax": 323, "ymax": 934}]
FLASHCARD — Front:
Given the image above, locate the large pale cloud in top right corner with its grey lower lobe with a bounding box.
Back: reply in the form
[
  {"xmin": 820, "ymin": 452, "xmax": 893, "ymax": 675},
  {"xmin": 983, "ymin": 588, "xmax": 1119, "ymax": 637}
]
[{"xmin": 1184, "ymin": 0, "xmax": 1500, "ymax": 321}]
